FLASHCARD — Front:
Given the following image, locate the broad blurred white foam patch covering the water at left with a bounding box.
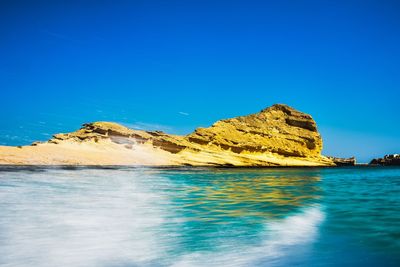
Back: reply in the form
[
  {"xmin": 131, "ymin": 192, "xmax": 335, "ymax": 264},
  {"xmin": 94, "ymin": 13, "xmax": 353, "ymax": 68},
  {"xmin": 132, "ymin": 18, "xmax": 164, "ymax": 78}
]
[{"xmin": 0, "ymin": 170, "xmax": 173, "ymax": 267}]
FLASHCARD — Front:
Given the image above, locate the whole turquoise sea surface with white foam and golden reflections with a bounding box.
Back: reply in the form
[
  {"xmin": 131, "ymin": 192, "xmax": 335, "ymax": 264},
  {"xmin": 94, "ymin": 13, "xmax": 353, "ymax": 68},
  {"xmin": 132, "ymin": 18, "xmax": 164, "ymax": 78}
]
[{"xmin": 0, "ymin": 166, "xmax": 400, "ymax": 267}]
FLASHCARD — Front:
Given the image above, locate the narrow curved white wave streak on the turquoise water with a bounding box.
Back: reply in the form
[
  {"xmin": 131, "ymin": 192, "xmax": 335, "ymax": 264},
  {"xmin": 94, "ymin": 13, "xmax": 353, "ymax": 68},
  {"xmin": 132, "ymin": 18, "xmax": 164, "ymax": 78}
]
[{"xmin": 172, "ymin": 205, "xmax": 325, "ymax": 267}]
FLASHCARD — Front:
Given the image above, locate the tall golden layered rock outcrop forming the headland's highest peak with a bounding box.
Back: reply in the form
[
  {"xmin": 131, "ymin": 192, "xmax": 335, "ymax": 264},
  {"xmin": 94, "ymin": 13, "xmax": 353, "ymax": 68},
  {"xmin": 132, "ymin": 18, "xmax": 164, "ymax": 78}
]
[{"xmin": 185, "ymin": 104, "xmax": 322, "ymax": 157}]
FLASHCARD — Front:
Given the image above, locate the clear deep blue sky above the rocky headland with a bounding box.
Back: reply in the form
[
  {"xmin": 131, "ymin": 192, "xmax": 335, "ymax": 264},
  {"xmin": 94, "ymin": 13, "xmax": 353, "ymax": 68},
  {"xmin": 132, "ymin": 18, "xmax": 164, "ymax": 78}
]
[{"xmin": 0, "ymin": 0, "xmax": 400, "ymax": 161}]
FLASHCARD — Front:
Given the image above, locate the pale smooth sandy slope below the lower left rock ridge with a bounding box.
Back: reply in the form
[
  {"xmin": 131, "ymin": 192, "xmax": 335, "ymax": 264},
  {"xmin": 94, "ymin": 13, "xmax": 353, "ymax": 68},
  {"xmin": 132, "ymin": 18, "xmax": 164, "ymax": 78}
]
[{"xmin": 0, "ymin": 141, "xmax": 180, "ymax": 165}]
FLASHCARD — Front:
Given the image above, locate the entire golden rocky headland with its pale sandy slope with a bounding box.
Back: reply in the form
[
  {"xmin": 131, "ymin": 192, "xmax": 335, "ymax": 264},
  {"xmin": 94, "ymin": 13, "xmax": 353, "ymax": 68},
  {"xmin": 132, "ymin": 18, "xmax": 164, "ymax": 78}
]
[{"xmin": 0, "ymin": 104, "xmax": 335, "ymax": 166}]
